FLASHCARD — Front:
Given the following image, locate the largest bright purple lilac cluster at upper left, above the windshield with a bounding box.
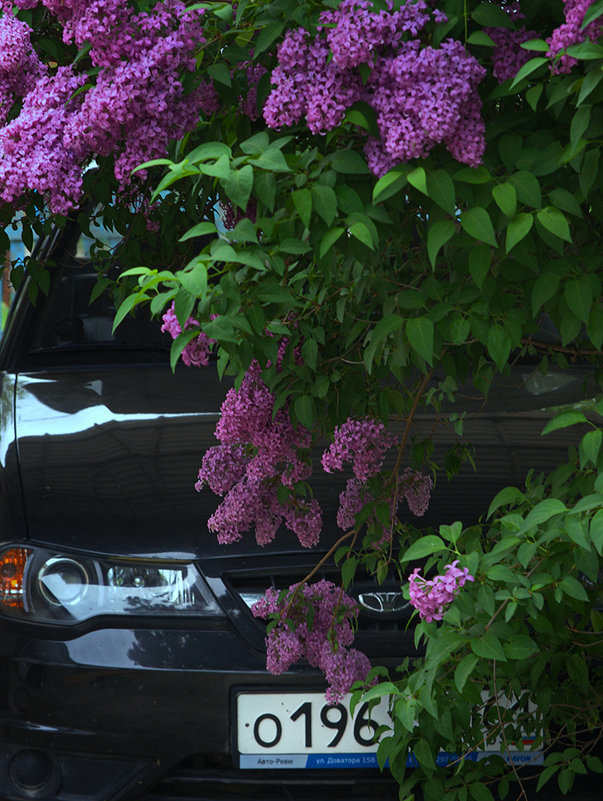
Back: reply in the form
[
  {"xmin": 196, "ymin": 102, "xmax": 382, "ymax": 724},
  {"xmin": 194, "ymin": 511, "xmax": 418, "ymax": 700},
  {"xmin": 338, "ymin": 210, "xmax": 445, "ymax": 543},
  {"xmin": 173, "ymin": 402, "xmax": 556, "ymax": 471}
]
[{"xmin": 0, "ymin": 0, "xmax": 206, "ymax": 214}]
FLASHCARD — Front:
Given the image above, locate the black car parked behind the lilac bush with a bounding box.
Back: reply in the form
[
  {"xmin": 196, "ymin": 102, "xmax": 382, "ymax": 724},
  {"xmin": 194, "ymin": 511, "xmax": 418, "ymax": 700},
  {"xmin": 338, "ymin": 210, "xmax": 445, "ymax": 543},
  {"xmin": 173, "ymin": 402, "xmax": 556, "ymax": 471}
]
[{"xmin": 0, "ymin": 231, "xmax": 596, "ymax": 801}]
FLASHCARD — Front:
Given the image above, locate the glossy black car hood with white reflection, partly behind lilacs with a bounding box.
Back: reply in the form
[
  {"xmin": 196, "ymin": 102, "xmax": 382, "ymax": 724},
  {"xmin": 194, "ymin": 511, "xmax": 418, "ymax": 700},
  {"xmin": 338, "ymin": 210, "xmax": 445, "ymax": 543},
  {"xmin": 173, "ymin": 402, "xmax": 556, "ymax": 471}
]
[{"xmin": 15, "ymin": 364, "xmax": 596, "ymax": 558}]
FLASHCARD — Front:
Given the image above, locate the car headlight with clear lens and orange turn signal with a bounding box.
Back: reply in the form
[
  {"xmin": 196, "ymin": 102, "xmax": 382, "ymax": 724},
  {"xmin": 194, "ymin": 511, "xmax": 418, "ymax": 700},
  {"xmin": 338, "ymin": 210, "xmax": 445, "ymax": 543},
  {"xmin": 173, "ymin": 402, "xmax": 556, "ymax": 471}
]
[{"xmin": 0, "ymin": 545, "xmax": 222, "ymax": 624}]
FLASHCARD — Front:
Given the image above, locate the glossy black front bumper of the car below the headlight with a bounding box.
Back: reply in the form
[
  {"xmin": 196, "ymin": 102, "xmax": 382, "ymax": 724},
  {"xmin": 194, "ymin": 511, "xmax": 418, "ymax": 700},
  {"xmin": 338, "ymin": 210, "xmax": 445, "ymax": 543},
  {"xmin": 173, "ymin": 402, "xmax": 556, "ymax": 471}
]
[{"xmin": 0, "ymin": 628, "xmax": 397, "ymax": 801}]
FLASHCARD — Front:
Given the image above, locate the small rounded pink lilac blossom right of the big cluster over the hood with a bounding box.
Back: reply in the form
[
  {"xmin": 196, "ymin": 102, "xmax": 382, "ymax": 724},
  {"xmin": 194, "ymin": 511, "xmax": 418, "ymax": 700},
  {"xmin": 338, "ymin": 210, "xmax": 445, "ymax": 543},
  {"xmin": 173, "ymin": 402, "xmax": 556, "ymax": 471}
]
[{"xmin": 321, "ymin": 417, "xmax": 396, "ymax": 481}]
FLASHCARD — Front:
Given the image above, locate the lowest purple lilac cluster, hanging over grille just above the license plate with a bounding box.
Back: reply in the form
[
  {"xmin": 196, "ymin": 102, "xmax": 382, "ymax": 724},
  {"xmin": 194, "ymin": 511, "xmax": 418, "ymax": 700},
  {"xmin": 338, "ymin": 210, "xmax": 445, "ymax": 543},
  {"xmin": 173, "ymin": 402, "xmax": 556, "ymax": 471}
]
[{"xmin": 252, "ymin": 579, "xmax": 371, "ymax": 704}]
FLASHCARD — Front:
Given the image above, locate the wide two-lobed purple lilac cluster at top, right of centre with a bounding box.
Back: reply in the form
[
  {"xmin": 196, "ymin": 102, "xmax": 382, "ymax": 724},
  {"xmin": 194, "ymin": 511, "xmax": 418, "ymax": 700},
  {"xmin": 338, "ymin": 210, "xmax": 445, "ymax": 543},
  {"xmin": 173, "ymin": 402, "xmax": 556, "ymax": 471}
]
[{"xmin": 264, "ymin": 0, "xmax": 485, "ymax": 175}]
